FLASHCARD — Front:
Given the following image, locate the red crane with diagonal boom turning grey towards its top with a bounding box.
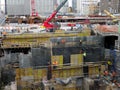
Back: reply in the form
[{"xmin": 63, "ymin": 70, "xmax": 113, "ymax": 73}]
[{"xmin": 43, "ymin": 0, "xmax": 68, "ymax": 29}]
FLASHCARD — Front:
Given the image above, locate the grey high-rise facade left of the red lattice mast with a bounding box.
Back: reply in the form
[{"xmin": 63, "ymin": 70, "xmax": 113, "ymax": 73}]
[{"xmin": 6, "ymin": 0, "xmax": 30, "ymax": 15}]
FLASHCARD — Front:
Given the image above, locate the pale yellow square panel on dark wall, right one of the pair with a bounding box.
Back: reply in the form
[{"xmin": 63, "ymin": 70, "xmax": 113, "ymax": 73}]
[{"xmin": 70, "ymin": 54, "xmax": 83, "ymax": 66}]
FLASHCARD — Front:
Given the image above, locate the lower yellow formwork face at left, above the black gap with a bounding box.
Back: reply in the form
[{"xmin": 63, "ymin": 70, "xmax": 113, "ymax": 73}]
[{"xmin": 2, "ymin": 37, "xmax": 49, "ymax": 48}]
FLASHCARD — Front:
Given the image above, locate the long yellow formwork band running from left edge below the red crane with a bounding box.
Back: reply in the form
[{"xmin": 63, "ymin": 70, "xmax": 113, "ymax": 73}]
[{"xmin": 2, "ymin": 30, "xmax": 90, "ymax": 48}]
